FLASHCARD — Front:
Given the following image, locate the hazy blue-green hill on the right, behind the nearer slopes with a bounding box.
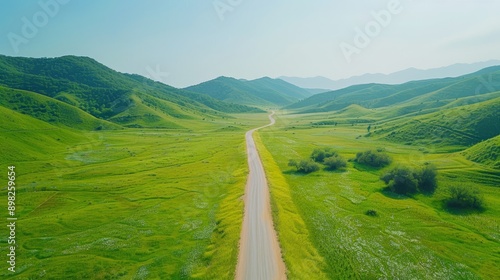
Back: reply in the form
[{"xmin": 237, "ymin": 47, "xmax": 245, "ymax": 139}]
[{"xmin": 286, "ymin": 66, "xmax": 500, "ymax": 115}]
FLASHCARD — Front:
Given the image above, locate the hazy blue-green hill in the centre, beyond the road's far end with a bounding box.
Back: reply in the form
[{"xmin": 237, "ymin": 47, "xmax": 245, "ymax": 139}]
[{"xmin": 186, "ymin": 77, "xmax": 310, "ymax": 106}]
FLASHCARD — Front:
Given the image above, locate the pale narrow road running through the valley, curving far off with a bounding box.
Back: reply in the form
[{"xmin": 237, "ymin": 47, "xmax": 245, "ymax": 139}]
[{"xmin": 236, "ymin": 112, "xmax": 286, "ymax": 280}]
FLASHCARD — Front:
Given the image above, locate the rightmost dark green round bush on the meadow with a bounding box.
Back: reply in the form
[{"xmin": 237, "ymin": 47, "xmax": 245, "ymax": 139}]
[{"xmin": 446, "ymin": 186, "xmax": 484, "ymax": 210}]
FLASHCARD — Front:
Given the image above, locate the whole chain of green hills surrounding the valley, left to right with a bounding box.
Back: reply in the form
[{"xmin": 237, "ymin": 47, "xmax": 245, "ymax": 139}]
[{"xmin": 0, "ymin": 55, "xmax": 500, "ymax": 168}]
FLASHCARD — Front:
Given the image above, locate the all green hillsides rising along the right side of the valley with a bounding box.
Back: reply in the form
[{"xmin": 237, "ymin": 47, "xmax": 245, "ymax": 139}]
[{"xmin": 283, "ymin": 66, "xmax": 500, "ymax": 160}]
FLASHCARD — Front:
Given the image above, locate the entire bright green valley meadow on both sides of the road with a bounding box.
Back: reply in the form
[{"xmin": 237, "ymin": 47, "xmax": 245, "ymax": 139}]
[{"xmin": 0, "ymin": 100, "xmax": 500, "ymax": 279}]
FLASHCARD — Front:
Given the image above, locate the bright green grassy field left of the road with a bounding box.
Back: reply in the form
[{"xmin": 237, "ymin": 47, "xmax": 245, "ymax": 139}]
[{"xmin": 0, "ymin": 110, "xmax": 267, "ymax": 279}]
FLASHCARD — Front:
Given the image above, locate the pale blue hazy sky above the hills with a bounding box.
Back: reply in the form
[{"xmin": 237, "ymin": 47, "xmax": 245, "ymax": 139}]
[{"xmin": 0, "ymin": 0, "xmax": 500, "ymax": 87}]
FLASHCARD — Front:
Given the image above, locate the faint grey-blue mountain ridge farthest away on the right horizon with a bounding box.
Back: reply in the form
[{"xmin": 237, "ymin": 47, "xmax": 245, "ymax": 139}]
[{"xmin": 279, "ymin": 60, "xmax": 500, "ymax": 90}]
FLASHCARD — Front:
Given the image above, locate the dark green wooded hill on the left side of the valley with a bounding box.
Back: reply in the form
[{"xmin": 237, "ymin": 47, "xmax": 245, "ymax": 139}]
[{"xmin": 0, "ymin": 56, "xmax": 259, "ymax": 128}]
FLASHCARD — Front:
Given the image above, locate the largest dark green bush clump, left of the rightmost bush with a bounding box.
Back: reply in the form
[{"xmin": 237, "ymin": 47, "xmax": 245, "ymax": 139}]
[{"xmin": 380, "ymin": 164, "xmax": 437, "ymax": 194}]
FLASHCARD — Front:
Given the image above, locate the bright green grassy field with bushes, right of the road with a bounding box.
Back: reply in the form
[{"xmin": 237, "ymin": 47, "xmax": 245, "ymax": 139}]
[{"xmin": 257, "ymin": 110, "xmax": 500, "ymax": 279}]
